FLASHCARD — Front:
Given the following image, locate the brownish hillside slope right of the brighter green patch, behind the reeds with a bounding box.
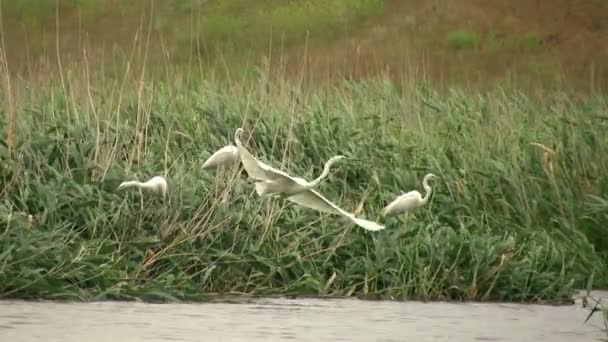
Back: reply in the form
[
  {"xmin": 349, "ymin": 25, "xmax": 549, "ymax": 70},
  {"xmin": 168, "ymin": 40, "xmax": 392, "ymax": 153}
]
[{"xmin": 293, "ymin": 0, "xmax": 608, "ymax": 89}]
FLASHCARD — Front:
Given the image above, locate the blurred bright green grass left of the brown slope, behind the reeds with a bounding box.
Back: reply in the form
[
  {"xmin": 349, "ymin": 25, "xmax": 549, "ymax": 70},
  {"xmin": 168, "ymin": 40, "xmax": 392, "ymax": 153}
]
[{"xmin": 0, "ymin": 0, "xmax": 385, "ymax": 70}]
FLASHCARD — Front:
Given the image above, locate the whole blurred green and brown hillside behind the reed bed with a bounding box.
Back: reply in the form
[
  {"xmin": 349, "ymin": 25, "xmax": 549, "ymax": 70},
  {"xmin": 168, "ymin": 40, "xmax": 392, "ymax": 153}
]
[{"xmin": 0, "ymin": 0, "xmax": 608, "ymax": 93}]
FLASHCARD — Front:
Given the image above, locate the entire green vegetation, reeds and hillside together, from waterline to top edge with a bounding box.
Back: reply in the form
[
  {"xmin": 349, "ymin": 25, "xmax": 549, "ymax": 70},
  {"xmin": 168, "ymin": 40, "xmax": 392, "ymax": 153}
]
[{"xmin": 0, "ymin": 0, "xmax": 608, "ymax": 306}]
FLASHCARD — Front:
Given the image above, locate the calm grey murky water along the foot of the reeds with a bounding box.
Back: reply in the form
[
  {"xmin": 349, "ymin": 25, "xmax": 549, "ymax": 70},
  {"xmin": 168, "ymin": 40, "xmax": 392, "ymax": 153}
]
[{"xmin": 0, "ymin": 293, "xmax": 608, "ymax": 342}]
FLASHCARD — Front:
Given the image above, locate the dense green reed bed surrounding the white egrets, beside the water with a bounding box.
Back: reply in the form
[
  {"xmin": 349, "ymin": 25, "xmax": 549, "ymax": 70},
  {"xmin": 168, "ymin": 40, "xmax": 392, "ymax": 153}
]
[{"xmin": 0, "ymin": 67, "xmax": 608, "ymax": 301}]
